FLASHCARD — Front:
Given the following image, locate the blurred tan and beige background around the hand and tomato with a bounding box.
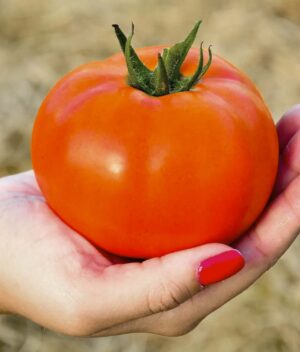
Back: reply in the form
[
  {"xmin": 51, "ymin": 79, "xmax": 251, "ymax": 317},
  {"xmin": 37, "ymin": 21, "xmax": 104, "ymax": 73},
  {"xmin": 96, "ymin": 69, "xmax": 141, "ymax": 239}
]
[{"xmin": 0, "ymin": 0, "xmax": 300, "ymax": 352}]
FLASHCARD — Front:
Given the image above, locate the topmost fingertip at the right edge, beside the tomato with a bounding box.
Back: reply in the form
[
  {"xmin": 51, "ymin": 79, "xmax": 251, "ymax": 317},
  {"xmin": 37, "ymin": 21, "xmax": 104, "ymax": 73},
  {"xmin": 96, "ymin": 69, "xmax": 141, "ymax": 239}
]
[{"xmin": 277, "ymin": 104, "xmax": 300, "ymax": 150}]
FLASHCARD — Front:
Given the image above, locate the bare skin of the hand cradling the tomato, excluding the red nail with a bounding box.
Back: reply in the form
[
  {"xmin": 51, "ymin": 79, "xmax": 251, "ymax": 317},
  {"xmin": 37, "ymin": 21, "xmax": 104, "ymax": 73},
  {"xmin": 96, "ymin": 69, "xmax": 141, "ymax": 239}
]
[{"xmin": 0, "ymin": 105, "xmax": 300, "ymax": 336}]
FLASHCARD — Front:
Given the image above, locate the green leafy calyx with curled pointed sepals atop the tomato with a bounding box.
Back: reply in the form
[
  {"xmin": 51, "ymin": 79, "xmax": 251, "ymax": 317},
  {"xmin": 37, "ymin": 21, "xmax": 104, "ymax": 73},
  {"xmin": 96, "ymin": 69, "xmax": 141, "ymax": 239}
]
[{"xmin": 113, "ymin": 21, "xmax": 212, "ymax": 97}]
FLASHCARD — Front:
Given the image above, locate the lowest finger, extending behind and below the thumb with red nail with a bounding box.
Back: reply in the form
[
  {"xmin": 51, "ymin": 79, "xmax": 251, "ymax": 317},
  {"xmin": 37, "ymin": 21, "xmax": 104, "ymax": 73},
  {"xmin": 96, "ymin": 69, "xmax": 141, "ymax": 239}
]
[{"xmin": 98, "ymin": 178, "xmax": 300, "ymax": 336}]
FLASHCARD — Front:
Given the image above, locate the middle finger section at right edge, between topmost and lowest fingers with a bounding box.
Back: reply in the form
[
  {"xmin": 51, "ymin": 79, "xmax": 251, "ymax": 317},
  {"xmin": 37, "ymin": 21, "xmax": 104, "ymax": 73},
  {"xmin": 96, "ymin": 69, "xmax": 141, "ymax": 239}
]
[{"xmin": 274, "ymin": 129, "xmax": 300, "ymax": 195}]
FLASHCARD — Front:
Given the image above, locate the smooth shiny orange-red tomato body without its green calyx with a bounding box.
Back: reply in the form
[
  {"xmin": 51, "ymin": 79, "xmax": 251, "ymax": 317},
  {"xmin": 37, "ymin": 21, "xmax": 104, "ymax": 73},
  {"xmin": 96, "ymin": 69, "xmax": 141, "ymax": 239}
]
[{"xmin": 32, "ymin": 47, "xmax": 278, "ymax": 258}]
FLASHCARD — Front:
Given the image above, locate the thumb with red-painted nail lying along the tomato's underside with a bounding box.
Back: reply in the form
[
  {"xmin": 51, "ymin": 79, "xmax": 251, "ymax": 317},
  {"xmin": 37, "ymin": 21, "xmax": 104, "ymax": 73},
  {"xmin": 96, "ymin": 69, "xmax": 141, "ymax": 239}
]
[{"xmin": 92, "ymin": 243, "xmax": 244, "ymax": 324}]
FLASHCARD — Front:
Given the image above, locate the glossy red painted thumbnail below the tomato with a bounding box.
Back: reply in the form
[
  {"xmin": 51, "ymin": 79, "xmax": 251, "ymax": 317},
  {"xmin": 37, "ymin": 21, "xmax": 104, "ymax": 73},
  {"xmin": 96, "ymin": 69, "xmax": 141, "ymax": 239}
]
[{"xmin": 198, "ymin": 249, "xmax": 245, "ymax": 286}]
